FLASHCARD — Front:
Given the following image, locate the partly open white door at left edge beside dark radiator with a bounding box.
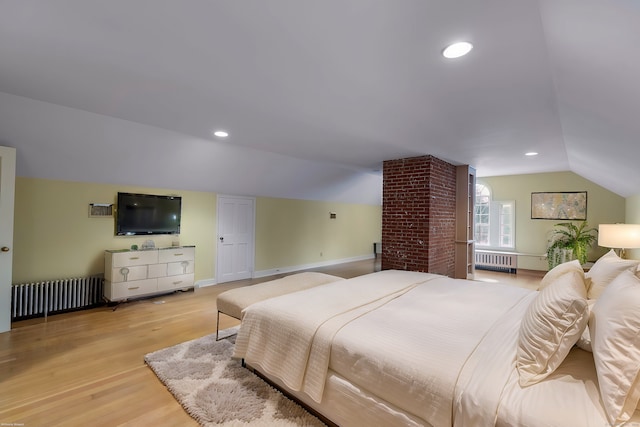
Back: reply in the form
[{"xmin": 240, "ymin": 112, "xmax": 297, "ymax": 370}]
[{"xmin": 0, "ymin": 146, "xmax": 16, "ymax": 332}]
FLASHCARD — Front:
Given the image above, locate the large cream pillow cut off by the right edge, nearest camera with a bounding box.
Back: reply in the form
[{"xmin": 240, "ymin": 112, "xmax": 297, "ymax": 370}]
[{"xmin": 589, "ymin": 271, "xmax": 640, "ymax": 425}]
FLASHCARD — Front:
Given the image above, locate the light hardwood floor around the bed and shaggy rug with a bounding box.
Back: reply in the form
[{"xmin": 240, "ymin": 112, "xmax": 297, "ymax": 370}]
[{"xmin": 0, "ymin": 260, "xmax": 541, "ymax": 427}]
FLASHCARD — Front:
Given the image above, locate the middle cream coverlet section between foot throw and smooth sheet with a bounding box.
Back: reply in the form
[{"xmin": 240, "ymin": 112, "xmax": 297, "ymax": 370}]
[{"xmin": 330, "ymin": 277, "xmax": 532, "ymax": 426}]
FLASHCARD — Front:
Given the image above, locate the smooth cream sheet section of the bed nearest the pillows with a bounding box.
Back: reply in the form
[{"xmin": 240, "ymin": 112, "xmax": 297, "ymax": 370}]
[{"xmin": 454, "ymin": 294, "xmax": 640, "ymax": 427}]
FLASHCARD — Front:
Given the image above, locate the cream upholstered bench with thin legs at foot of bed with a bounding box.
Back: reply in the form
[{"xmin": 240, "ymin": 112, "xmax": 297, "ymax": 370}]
[{"xmin": 216, "ymin": 272, "xmax": 344, "ymax": 340}]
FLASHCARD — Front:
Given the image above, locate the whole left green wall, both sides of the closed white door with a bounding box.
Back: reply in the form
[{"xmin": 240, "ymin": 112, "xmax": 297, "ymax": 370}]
[{"xmin": 12, "ymin": 177, "xmax": 382, "ymax": 283}]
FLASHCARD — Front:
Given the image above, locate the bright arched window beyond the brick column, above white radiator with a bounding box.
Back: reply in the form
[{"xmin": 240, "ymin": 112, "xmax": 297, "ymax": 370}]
[{"xmin": 474, "ymin": 184, "xmax": 516, "ymax": 249}]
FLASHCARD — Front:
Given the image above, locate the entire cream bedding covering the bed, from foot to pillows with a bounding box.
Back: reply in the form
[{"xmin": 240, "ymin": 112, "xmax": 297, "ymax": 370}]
[{"xmin": 235, "ymin": 270, "xmax": 640, "ymax": 427}]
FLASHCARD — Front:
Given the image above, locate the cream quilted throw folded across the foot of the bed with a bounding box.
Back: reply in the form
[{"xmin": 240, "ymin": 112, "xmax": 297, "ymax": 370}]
[{"xmin": 234, "ymin": 270, "xmax": 441, "ymax": 402}]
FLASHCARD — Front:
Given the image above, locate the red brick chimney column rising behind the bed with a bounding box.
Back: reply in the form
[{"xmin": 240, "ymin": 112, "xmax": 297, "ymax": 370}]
[{"xmin": 382, "ymin": 156, "xmax": 456, "ymax": 277}]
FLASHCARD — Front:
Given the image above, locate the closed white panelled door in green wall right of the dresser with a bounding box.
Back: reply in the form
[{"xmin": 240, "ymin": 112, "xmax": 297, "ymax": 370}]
[{"xmin": 216, "ymin": 196, "xmax": 255, "ymax": 283}]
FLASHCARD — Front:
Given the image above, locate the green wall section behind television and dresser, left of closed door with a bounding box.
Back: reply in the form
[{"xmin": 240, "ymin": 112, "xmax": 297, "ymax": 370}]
[{"xmin": 13, "ymin": 177, "xmax": 216, "ymax": 283}]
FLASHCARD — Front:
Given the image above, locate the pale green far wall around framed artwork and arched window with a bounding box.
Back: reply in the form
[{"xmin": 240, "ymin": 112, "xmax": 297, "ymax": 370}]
[{"xmin": 477, "ymin": 172, "xmax": 624, "ymax": 270}]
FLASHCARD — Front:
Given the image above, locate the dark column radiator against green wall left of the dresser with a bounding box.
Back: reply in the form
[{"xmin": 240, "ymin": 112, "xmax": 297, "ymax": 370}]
[{"xmin": 11, "ymin": 275, "xmax": 104, "ymax": 320}]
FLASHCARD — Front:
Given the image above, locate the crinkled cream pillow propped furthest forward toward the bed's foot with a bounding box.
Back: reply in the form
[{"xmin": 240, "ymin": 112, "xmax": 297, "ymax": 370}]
[{"xmin": 516, "ymin": 272, "xmax": 589, "ymax": 387}]
